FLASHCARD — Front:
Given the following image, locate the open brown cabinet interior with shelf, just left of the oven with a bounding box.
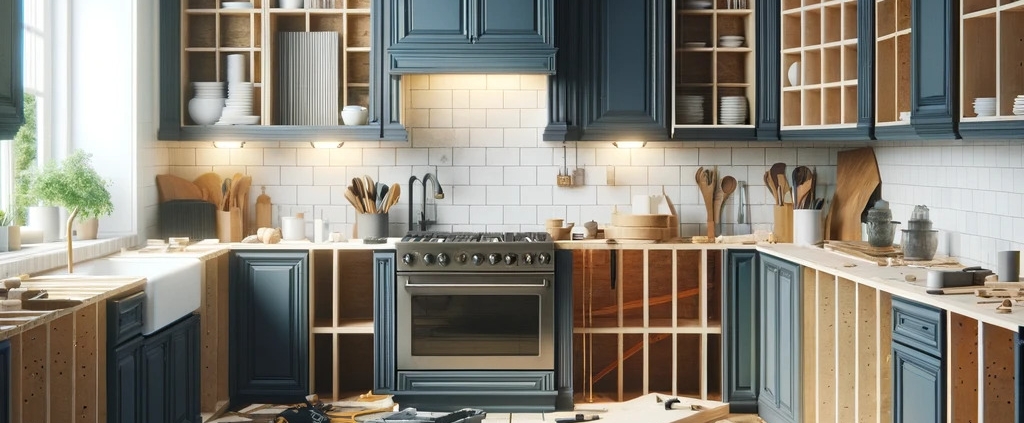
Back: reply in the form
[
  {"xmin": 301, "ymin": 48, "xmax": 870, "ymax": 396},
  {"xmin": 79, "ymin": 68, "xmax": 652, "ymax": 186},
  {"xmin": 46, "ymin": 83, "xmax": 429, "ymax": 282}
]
[{"xmin": 309, "ymin": 250, "xmax": 374, "ymax": 401}]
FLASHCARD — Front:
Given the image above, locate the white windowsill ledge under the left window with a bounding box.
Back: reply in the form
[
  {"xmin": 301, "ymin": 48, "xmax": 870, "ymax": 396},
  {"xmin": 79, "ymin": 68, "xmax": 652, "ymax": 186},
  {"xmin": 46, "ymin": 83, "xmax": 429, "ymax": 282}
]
[{"xmin": 0, "ymin": 237, "xmax": 136, "ymax": 278}]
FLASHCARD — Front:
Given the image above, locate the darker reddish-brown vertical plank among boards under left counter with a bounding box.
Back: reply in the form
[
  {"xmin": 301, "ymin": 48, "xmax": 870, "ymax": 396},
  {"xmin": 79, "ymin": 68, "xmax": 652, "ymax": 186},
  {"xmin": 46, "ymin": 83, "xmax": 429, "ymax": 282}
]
[{"xmin": 46, "ymin": 314, "xmax": 75, "ymax": 422}]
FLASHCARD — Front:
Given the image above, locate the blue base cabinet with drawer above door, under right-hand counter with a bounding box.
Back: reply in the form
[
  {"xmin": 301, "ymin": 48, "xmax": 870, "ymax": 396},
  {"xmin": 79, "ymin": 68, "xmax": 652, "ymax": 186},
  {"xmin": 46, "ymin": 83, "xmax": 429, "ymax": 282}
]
[{"xmin": 892, "ymin": 296, "xmax": 946, "ymax": 423}]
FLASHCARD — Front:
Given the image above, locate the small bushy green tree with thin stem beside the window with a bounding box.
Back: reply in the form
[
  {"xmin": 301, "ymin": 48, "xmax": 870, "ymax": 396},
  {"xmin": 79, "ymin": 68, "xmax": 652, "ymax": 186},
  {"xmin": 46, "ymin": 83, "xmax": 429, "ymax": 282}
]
[{"xmin": 32, "ymin": 150, "xmax": 114, "ymax": 273}]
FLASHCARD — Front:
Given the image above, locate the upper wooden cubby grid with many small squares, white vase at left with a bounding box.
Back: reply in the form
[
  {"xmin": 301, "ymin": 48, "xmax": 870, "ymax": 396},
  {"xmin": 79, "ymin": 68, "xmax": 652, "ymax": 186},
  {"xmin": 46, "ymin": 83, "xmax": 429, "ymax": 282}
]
[{"xmin": 779, "ymin": 0, "xmax": 858, "ymax": 130}]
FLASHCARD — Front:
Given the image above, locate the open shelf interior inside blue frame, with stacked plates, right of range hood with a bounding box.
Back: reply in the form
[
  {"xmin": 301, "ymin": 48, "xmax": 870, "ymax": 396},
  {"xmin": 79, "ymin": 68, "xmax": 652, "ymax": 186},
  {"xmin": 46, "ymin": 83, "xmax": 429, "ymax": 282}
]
[{"xmin": 672, "ymin": 0, "xmax": 757, "ymax": 128}]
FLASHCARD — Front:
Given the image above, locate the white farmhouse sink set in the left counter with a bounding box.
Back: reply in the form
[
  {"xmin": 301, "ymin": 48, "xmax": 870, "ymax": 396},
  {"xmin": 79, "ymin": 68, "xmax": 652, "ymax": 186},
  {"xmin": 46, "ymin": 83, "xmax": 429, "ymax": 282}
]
[{"xmin": 43, "ymin": 257, "xmax": 202, "ymax": 335}]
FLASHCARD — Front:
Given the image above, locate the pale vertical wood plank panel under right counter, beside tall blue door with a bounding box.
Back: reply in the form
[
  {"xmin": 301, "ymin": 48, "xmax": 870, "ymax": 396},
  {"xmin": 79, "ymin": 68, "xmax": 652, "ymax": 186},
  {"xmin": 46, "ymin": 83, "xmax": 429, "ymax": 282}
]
[{"xmin": 796, "ymin": 267, "xmax": 893, "ymax": 423}]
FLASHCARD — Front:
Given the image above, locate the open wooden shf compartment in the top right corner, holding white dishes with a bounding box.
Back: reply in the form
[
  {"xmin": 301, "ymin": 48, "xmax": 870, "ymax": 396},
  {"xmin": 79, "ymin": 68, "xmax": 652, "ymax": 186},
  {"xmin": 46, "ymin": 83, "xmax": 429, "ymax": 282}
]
[{"xmin": 959, "ymin": 0, "xmax": 1024, "ymax": 122}]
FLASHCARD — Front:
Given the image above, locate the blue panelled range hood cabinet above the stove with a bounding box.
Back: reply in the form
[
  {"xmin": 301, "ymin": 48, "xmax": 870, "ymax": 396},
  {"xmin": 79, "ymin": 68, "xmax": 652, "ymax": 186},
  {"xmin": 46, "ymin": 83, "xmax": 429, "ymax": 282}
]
[{"xmin": 386, "ymin": 0, "xmax": 555, "ymax": 74}]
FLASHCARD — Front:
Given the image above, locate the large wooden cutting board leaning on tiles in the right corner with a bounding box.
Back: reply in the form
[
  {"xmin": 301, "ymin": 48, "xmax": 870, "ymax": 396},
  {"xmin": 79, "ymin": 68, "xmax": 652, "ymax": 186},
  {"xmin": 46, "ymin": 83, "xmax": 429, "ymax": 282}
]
[{"xmin": 825, "ymin": 146, "xmax": 882, "ymax": 241}]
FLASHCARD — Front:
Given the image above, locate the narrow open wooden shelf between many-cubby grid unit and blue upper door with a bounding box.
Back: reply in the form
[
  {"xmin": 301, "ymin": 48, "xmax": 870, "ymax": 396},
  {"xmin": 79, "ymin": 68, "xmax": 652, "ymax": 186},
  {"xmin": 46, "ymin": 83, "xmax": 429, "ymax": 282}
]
[{"xmin": 874, "ymin": 0, "xmax": 911, "ymax": 126}]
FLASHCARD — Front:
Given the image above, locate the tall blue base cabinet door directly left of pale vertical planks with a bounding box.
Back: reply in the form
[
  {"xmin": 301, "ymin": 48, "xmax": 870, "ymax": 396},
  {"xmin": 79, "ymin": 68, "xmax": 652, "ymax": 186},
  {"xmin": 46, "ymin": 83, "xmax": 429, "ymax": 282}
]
[{"xmin": 758, "ymin": 255, "xmax": 803, "ymax": 423}]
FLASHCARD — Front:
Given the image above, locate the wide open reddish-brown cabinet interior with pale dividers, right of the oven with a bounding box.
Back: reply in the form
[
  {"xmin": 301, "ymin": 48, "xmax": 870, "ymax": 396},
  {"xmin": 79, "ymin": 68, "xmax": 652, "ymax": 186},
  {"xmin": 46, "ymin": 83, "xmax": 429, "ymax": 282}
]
[{"xmin": 572, "ymin": 245, "xmax": 723, "ymax": 405}]
